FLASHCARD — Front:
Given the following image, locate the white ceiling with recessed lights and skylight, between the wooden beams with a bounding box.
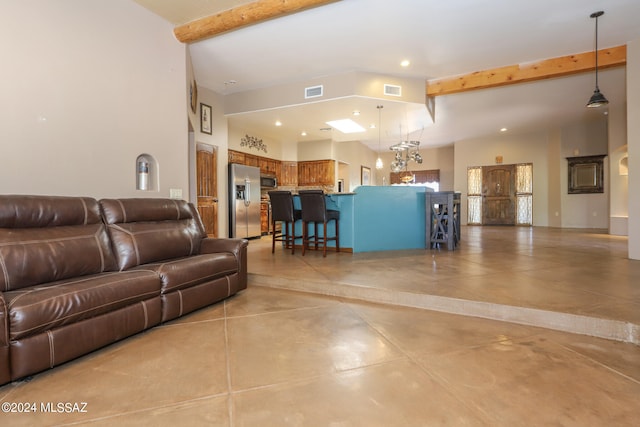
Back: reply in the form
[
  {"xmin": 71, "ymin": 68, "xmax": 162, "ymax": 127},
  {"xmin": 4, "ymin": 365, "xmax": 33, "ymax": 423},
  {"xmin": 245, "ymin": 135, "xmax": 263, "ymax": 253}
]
[{"xmin": 135, "ymin": 0, "xmax": 640, "ymax": 150}]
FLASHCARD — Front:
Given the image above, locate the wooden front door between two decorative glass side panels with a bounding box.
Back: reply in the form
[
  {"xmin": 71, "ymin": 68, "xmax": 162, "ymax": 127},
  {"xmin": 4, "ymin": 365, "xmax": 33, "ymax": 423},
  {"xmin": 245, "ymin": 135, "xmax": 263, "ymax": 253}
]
[{"xmin": 482, "ymin": 165, "xmax": 516, "ymax": 225}]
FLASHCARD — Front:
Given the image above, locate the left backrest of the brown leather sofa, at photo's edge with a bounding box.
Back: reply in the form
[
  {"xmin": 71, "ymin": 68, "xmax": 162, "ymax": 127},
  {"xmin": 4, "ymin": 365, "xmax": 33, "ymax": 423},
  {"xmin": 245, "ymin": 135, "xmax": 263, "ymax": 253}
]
[{"xmin": 0, "ymin": 195, "xmax": 116, "ymax": 291}]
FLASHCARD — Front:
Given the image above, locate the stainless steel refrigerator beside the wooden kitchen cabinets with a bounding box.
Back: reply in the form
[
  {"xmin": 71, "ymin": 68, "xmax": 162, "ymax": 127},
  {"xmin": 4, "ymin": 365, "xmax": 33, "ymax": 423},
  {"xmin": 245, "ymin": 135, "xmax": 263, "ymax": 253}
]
[{"xmin": 229, "ymin": 164, "xmax": 262, "ymax": 238}]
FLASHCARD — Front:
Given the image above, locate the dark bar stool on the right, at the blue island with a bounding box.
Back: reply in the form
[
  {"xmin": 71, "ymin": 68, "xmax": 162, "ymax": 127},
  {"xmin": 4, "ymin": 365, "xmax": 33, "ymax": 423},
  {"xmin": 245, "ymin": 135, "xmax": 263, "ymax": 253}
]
[{"xmin": 298, "ymin": 190, "xmax": 340, "ymax": 257}]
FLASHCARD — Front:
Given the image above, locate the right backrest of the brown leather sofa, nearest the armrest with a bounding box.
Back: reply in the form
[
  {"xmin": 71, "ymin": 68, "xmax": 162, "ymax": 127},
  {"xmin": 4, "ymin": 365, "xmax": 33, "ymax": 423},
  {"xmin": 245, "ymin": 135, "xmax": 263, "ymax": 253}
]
[{"xmin": 100, "ymin": 199, "xmax": 206, "ymax": 270}]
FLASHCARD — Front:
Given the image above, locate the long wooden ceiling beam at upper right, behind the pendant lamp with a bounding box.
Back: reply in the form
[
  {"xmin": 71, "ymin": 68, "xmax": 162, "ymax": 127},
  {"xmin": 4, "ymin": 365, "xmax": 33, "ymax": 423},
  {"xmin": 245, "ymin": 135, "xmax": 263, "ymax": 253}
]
[{"xmin": 426, "ymin": 45, "xmax": 627, "ymax": 97}]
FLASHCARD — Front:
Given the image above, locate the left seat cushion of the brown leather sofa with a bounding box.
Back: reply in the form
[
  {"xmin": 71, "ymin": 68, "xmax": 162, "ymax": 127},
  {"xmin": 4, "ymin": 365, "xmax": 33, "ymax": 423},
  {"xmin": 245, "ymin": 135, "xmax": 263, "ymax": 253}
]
[{"xmin": 4, "ymin": 270, "xmax": 160, "ymax": 340}]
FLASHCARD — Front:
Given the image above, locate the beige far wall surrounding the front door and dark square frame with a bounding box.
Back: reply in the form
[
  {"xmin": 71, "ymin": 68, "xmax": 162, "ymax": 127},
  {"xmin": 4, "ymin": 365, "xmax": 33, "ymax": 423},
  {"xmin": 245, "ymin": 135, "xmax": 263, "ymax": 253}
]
[{"xmin": 455, "ymin": 115, "xmax": 609, "ymax": 229}]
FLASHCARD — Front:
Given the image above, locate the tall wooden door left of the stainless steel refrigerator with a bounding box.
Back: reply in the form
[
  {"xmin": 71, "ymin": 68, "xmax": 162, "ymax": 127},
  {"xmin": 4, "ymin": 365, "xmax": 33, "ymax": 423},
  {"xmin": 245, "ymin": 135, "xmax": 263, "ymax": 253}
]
[{"xmin": 196, "ymin": 144, "xmax": 218, "ymax": 237}]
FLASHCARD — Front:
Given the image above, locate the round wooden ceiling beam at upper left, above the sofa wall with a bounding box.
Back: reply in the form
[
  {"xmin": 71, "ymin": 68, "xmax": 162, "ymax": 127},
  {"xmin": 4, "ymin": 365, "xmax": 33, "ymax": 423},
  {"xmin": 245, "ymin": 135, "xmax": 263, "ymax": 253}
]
[{"xmin": 173, "ymin": 0, "xmax": 340, "ymax": 43}]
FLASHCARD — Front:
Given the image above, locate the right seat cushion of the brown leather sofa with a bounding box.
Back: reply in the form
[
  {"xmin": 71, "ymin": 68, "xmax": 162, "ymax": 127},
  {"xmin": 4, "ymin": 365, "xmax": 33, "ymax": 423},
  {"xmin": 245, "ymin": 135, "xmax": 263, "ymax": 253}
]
[{"xmin": 138, "ymin": 252, "xmax": 238, "ymax": 294}]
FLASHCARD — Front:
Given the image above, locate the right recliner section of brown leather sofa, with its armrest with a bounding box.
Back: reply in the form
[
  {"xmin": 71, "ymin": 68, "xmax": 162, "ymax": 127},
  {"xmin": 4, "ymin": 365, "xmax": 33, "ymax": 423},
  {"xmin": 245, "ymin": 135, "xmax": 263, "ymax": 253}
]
[{"xmin": 100, "ymin": 199, "xmax": 247, "ymax": 322}]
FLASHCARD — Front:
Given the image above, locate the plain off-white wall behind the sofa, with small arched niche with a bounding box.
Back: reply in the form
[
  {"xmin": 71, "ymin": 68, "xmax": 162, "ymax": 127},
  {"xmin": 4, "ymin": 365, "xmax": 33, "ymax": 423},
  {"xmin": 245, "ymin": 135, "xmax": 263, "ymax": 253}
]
[{"xmin": 0, "ymin": 0, "xmax": 189, "ymax": 198}]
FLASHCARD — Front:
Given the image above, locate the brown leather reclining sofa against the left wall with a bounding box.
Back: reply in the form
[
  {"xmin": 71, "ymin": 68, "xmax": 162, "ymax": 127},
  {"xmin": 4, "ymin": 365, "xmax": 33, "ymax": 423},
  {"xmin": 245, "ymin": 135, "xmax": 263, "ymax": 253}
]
[{"xmin": 0, "ymin": 195, "xmax": 247, "ymax": 384}]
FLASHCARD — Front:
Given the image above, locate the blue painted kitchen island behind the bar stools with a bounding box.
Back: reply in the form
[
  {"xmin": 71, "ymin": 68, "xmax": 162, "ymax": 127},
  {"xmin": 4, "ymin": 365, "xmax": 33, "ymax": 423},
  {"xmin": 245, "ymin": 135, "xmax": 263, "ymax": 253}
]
[{"xmin": 293, "ymin": 186, "xmax": 433, "ymax": 253}]
